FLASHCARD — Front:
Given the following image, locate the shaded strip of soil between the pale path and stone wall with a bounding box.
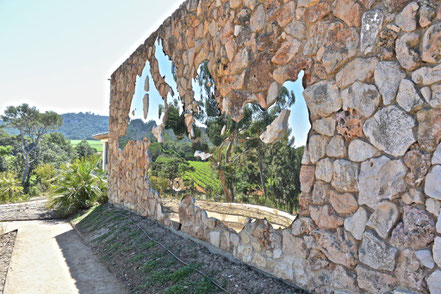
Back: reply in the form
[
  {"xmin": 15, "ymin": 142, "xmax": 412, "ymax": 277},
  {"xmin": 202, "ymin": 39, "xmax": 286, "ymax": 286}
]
[{"xmin": 72, "ymin": 204, "xmax": 306, "ymax": 294}]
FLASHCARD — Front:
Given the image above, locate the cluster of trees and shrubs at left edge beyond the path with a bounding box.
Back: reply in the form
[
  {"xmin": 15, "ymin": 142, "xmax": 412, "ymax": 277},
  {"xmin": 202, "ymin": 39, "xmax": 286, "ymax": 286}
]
[{"xmin": 0, "ymin": 104, "xmax": 96, "ymax": 202}]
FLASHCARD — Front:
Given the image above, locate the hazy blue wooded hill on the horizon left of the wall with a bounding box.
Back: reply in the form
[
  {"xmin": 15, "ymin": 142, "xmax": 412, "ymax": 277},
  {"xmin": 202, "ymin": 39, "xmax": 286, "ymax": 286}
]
[{"xmin": 57, "ymin": 112, "xmax": 109, "ymax": 140}]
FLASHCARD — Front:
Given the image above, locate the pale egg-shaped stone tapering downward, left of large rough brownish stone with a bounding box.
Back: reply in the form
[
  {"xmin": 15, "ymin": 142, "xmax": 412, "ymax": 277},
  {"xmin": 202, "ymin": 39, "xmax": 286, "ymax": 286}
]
[{"xmin": 367, "ymin": 201, "xmax": 400, "ymax": 239}]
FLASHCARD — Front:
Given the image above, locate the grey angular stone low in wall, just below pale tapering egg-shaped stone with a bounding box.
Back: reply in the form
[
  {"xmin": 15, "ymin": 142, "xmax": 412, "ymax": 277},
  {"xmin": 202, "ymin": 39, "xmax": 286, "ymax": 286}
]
[{"xmin": 358, "ymin": 231, "xmax": 398, "ymax": 271}]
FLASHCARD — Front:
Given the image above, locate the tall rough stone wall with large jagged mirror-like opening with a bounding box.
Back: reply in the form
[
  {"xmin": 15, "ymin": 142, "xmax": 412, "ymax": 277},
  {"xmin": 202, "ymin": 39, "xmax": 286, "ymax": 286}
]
[{"xmin": 109, "ymin": 0, "xmax": 441, "ymax": 293}]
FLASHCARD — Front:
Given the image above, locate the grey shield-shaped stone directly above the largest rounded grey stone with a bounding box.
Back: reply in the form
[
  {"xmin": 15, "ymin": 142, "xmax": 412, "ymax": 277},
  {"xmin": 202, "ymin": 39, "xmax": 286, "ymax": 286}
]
[{"xmin": 374, "ymin": 61, "xmax": 406, "ymax": 105}]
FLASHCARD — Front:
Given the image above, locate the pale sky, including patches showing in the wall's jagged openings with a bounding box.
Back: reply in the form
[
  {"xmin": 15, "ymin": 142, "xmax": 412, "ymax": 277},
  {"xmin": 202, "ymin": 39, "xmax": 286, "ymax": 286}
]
[{"xmin": 0, "ymin": 0, "xmax": 310, "ymax": 146}]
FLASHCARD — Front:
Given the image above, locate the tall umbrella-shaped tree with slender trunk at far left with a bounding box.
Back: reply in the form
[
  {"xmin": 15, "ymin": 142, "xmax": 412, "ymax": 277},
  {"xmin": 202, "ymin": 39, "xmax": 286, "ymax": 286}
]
[{"xmin": 1, "ymin": 104, "xmax": 63, "ymax": 192}]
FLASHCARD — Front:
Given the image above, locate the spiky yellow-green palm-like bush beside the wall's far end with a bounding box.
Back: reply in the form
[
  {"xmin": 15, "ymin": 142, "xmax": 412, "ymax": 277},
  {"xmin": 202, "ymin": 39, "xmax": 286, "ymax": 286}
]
[{"xmin": 50, "ymin": 156, "xmax": 107, "ymax": 216}]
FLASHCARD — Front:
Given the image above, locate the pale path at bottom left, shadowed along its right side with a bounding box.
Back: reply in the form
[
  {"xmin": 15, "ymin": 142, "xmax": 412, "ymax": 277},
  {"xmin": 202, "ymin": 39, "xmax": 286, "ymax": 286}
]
[{"xmin": 4, "ymin": 220, "xmax": 126, "ymax": 294}]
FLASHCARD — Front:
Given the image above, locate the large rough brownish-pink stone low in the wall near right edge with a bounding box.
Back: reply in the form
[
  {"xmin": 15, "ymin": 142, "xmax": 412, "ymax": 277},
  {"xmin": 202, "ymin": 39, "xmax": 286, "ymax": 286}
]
[{"xmin": 390, "ymin": 206, "xmax": 435, "ymax": 249}]
